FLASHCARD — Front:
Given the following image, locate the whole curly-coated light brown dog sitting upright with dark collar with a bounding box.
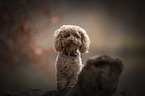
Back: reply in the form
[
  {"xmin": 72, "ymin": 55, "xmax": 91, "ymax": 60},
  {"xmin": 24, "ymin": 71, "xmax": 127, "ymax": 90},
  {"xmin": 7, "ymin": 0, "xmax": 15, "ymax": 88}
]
[{"xmin": 54, "ymin": 25, "xmax": 90, "ymax": 90}]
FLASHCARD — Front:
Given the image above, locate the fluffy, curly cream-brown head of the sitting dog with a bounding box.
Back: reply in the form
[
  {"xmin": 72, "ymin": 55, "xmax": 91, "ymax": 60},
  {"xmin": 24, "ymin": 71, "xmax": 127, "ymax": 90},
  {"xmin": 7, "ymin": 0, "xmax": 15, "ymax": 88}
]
[{"xmin": 54, "ymin": 25, "xmax": 90, "ymax": 53}]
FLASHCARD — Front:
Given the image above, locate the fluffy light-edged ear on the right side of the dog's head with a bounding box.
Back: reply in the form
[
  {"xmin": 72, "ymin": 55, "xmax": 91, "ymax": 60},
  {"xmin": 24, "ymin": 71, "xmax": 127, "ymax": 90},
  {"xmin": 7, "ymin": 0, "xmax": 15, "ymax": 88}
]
[{"xmin": 79, "ymin": 31, "xmax": 90, "ymax": 53}]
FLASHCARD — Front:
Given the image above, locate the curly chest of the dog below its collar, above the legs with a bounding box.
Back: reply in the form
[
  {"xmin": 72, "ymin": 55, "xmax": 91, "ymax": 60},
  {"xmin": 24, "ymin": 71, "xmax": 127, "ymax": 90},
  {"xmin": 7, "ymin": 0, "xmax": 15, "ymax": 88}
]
[{"xmin": 56, "ymin": 54, "xmax": 82, "ymax": 74}]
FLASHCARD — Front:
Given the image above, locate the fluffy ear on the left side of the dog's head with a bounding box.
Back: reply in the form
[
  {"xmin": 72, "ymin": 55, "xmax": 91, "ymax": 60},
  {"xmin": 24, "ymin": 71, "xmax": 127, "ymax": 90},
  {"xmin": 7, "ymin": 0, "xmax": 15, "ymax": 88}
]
[{"xmin": 54, "ymin": 30, "xmax": 63, "ymax": 52}]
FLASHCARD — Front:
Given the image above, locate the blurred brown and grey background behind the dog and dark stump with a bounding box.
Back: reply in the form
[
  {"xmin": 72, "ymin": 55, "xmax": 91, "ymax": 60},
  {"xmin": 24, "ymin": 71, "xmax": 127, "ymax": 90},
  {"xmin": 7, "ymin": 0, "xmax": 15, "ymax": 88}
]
[{"xmin": 0, "ymin": 0, "xmax": 145, "ymax": 96}]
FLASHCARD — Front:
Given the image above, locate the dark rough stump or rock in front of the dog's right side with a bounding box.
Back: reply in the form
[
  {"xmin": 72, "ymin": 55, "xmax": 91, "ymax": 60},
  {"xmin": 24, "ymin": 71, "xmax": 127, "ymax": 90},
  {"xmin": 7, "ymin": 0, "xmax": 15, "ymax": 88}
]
[{"xmin": 66, "ymin": 55, "xmax": 123, "ymax": 96}]
